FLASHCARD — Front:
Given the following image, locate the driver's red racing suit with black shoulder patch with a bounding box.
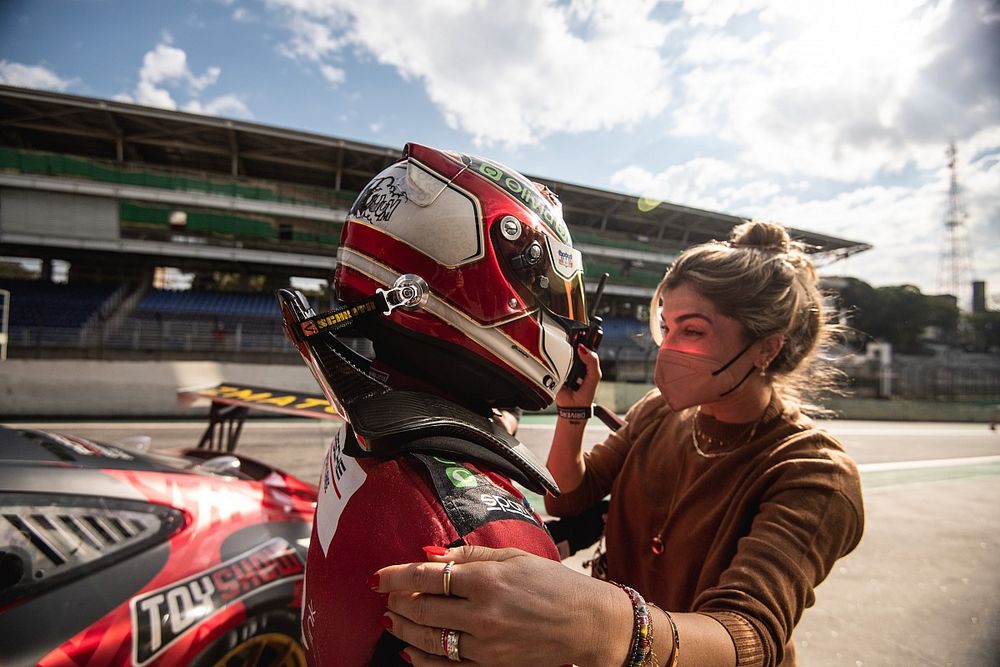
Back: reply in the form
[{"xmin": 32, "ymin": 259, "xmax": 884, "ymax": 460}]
[{"xmin": 302, "ymin": 427, "xmax": 559, "ymax": 667}]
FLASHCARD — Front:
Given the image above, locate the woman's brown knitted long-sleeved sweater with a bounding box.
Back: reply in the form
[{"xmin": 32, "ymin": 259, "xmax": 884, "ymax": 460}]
[{"xmin": 547, "ymin": 390, "xmax": 864, "ymax": 667}]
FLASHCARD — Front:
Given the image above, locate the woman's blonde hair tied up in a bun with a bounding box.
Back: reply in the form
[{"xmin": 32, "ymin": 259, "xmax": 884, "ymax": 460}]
[{"xmin": 649, "ymin": 220, "xmax": 838, "ymax": 411}]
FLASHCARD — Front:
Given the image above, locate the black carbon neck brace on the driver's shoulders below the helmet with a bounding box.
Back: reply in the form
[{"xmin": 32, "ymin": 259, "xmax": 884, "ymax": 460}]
[{"xmin": 275, "ymin": 289, "xmax": 559, "ymax": 496}]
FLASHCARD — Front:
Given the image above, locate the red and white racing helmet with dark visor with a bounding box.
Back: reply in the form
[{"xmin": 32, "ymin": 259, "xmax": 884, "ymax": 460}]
[{"xmin": 334, "ymin": 143, "xmax": 587, "ymax": 410}]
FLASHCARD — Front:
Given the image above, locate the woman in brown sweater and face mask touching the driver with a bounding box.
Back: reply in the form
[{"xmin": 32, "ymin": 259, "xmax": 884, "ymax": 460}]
[{"xmin": 373, "ymin": 222, "xmax": 864, "ymax": 666}]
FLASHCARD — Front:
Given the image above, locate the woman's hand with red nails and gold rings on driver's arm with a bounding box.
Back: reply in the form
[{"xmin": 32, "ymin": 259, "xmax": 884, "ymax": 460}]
[{"xmin": 372, "ymin": 546, "xmax": 632, "ymax": 667}]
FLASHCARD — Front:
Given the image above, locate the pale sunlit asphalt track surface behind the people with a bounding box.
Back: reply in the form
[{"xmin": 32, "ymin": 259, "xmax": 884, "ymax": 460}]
[{"xmin": 9, "ymin": 416, "xmax": 1000, "ymax": 667}]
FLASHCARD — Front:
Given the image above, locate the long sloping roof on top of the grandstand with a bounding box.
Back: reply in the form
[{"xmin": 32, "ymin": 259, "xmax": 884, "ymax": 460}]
[{"xmin": 0, "ymin": 85, "xmax": 871, "ymax": 263}]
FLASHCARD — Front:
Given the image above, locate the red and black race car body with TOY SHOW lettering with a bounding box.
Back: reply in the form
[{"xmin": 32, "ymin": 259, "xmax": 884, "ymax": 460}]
[{"xmin": 0, "ymin": 427, "xmax": 317, "ymax": 666}]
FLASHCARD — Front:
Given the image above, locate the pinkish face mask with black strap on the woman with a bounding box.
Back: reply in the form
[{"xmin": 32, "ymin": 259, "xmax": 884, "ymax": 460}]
[{"xmin": 653, "ymin": 342, "xmax": 756, "ymax": 410}]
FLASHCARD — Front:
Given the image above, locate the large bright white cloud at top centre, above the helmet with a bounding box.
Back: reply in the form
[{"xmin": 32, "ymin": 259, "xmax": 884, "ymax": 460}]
[{"xmin": 268, "ymin": 0, "xmax": 669, "ymax": 146}]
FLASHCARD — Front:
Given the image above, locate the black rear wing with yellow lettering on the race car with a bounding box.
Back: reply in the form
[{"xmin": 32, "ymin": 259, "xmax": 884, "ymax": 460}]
[{"xmin": 177, "ymin": 382, "xmax": 343, "ymax": 452}]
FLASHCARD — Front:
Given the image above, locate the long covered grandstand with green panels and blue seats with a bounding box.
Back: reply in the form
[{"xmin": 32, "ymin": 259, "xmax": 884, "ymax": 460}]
[{"xmin": 0, "ymin": 86, "xmax": 869, "ymax": 380}]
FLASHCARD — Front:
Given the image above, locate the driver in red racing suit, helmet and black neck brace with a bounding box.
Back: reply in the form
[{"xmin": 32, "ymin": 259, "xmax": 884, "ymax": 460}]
[{"xmin": 278, "ymin": 143, "xmax": 587, "ymax": 666}]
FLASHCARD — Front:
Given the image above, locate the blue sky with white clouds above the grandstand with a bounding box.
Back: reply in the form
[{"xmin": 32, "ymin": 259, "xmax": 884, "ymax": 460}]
[{"xmin": 0, "ymin": 0, "xmax": 1000, "ymax": 308}]
